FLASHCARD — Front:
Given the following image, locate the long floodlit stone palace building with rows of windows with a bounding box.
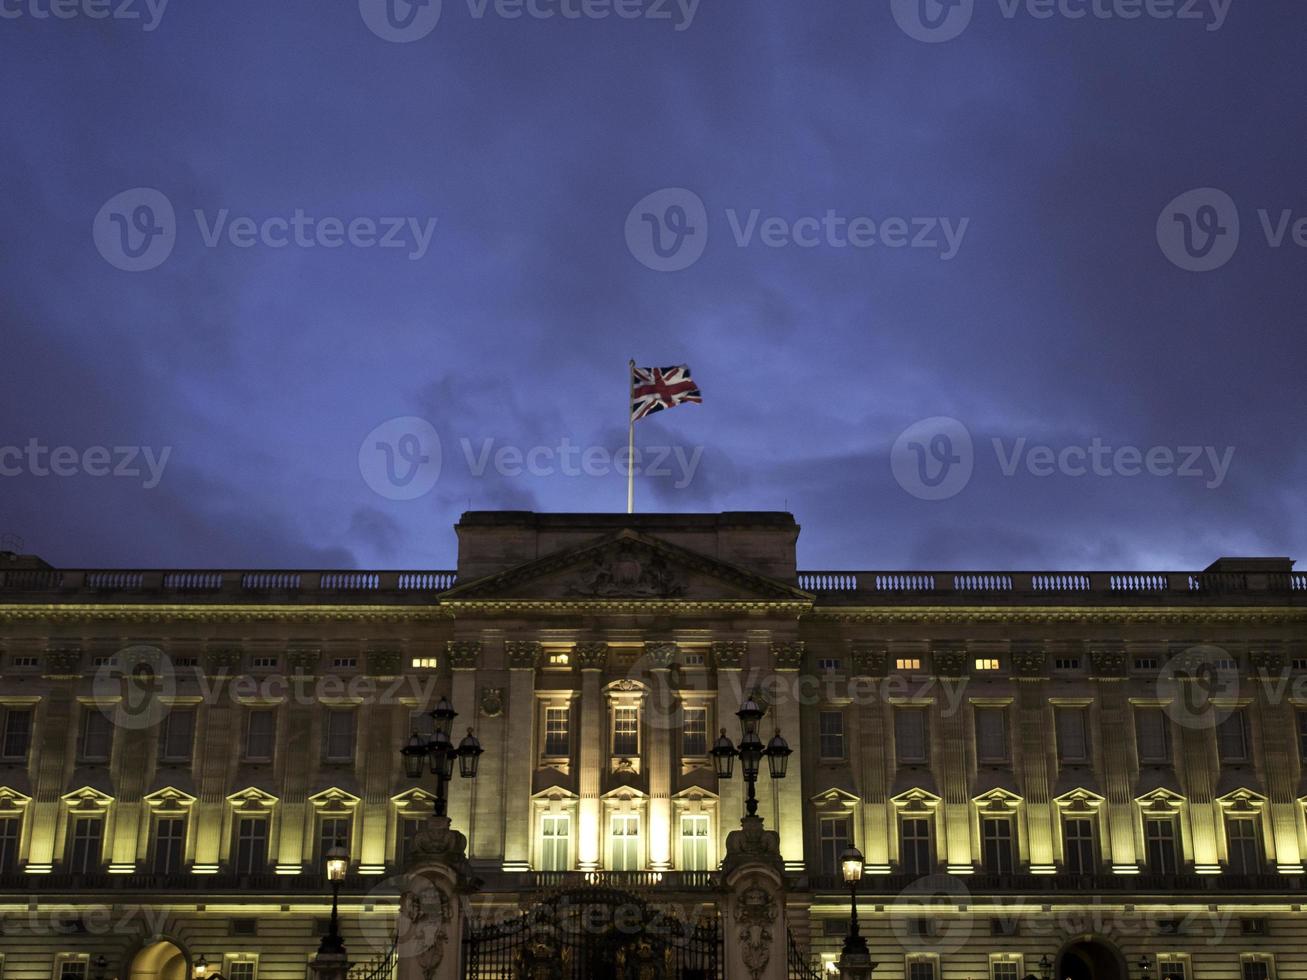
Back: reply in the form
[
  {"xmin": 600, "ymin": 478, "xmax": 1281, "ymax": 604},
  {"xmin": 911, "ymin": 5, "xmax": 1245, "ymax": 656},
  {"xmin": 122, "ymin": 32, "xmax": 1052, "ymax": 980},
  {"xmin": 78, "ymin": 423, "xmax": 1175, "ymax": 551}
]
[{"xmin": 0, "ymin": 512, "xmax": 1307, "ymax": 980}]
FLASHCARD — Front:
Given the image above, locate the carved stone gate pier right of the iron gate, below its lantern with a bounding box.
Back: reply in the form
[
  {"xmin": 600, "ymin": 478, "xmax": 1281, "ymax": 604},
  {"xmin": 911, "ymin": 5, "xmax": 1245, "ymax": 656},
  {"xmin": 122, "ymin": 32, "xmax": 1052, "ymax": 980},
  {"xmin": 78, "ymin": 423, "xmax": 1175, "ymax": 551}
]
[{"xmin": 721, "ymin": 817, "xmax": 789, "ymax": 980}]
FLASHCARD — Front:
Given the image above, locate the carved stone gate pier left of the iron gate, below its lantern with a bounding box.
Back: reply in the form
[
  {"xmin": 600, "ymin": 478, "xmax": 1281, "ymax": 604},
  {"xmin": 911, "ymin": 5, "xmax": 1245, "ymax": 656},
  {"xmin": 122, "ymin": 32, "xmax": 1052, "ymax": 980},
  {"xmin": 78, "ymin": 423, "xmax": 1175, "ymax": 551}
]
[{"xmin": 397, "ymin": 817, "xmax": 476, "ymax": 980}]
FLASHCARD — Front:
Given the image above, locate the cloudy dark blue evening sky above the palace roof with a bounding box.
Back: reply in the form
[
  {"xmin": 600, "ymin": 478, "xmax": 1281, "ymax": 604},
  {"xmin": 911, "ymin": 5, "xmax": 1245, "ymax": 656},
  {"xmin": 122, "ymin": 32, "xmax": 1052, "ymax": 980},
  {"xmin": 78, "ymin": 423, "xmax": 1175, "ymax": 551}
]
[{"xmin": 0, "ymin": 0, "xmax": 1307, "ymax": 568}]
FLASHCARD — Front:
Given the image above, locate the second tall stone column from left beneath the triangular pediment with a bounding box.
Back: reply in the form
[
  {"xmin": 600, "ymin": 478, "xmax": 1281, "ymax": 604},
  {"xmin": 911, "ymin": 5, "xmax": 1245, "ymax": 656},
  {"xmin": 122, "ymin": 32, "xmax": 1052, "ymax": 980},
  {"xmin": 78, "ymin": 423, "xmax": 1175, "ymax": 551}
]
[{"xmin": 503, "ymin": 640, "xmax": 540, "ymax": 872}]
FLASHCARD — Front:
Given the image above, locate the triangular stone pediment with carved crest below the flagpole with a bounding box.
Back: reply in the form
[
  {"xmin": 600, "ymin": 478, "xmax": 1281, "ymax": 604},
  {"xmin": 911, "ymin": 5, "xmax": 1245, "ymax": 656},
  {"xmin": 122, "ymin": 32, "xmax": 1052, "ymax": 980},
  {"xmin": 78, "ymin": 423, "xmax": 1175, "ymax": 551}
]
[{"xmin": 440, "ymin": 529, "xmax": 813, "ymax": 605}]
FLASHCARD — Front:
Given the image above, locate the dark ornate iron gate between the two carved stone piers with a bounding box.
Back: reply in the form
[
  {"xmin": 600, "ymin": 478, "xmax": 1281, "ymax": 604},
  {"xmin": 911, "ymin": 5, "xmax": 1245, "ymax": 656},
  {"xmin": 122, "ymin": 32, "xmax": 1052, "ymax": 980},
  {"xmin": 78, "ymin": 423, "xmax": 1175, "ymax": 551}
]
[{"xmin": 463, "ymin": 887, "xmax": 721, "ymax": 980}]
